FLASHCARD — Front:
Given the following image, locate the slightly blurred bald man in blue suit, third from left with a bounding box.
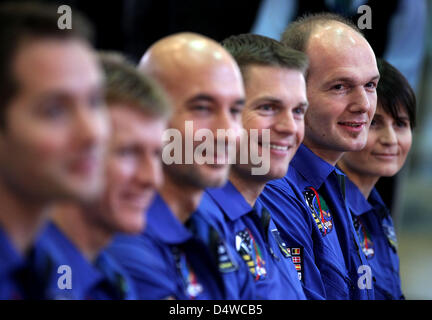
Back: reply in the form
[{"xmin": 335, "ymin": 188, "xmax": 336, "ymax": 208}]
[{"xmin": 110, "ymin": 33, "xmax": 255, "ymax": 299}]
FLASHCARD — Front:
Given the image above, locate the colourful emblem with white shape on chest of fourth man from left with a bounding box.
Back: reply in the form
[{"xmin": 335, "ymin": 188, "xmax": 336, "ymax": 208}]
[{"xmin": 235, "ymin": 228, "xmax": 267, "ymax": 281}]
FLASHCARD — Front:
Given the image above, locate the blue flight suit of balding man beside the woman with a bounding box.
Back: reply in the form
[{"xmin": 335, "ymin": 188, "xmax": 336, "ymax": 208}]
[{"xmin": 260, "ymin": 144, "xmax": 374, "ymax": 300}]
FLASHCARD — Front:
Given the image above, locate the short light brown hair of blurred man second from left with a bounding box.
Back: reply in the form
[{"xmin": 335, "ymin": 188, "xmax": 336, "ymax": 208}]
[{"xmin": 99, "ymin": 52, "xmax": 171, "ymax": 117}]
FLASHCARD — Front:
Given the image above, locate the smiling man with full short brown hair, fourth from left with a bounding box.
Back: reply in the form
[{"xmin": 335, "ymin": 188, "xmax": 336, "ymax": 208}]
[{"xmin": 201, "ymin": 34, "xmax": 307, "ymax": 299}]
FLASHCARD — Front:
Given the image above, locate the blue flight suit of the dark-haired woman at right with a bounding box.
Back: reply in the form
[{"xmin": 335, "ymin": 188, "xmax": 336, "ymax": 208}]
[{"xmin": 346, "ymin": 179, "xmax": 404, "ymax": 300}]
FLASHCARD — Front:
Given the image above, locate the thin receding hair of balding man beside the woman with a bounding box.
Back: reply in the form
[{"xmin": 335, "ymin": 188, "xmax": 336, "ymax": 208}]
[{"xmin": 281, "ymin": 12, "xmax": 364, "ymax": 52}]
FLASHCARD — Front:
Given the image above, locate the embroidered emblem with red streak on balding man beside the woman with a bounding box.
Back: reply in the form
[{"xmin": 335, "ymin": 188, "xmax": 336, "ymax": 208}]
[{"xmin": 303, "ymin": 187, "xmax": 333, "ymax": 236}]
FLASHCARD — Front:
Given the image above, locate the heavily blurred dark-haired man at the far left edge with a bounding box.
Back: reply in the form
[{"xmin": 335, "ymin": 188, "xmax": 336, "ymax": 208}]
[{"xmin": 0, "ymin": 3, "xmax": 107, "ymax": 299}]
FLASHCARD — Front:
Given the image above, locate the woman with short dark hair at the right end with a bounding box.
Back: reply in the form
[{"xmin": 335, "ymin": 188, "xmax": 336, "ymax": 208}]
[{"xmin": 338, "ymin": 59, "xmax": 416, "ymax": 299}]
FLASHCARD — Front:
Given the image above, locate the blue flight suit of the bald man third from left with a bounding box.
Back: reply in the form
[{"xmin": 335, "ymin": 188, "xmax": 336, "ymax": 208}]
[{"xmin": 108, "ymin": 195, "xmax": 255, "ymax": 300}]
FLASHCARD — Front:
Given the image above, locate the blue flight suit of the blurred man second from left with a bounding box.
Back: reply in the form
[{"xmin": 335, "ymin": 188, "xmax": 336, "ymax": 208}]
[{"xmin": 35, "ymin": 222, "xmax": 136, "ymax": 300}]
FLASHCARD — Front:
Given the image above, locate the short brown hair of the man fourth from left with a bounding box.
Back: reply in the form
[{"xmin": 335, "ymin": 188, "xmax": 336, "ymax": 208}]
[{"xmin": 222, "ymin": 34, "xmax": 308, "ymax": 77}]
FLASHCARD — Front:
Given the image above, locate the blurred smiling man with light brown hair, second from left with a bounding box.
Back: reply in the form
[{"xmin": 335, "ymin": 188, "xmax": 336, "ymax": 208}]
[{"xmin": 35, "ymin": 54, "xmax": 169, "ymax": 300}]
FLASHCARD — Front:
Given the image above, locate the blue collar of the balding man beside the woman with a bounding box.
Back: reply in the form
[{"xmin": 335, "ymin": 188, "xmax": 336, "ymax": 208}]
[{"xmin": 290, "ymin": 143, "xmax": 342, "ymax": 190}]
